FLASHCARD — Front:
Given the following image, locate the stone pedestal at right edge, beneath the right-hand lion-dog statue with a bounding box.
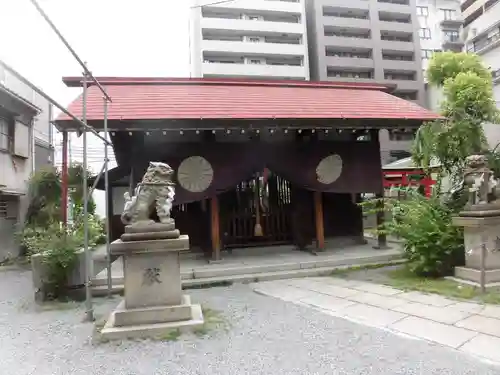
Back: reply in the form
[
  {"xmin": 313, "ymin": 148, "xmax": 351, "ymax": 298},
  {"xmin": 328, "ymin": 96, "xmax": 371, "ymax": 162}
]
[{"xmin": 453, "ymin": 215, "xmax": 500, "ymax": 286}]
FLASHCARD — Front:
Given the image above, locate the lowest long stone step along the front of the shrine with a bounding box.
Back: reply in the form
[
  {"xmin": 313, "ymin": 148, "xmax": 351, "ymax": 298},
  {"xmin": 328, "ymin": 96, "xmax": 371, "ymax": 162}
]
[{"xmin": 92, "ymin": 259, "xmax": 404, "ymax": 297}]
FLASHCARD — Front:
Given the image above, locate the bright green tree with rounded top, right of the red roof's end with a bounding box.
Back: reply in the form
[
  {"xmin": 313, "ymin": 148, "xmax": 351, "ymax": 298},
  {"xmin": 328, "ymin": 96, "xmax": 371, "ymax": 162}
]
[{"xmin": 413, "ymin": 52, "xmax": 499, "ymax": 181}]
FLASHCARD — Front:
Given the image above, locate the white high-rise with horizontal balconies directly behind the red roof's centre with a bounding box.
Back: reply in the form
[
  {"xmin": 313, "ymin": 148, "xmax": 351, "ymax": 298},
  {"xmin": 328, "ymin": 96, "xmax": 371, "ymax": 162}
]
[{"xmin": 190, "ymin": 0, "xmax": 309, "ymax": 80}]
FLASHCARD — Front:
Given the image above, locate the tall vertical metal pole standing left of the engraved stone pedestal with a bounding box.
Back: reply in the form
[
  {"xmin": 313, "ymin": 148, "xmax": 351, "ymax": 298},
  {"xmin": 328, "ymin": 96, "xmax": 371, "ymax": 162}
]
[{"xmin": 82, "ymin": 72, "xmax": 94, "ymax": 322}]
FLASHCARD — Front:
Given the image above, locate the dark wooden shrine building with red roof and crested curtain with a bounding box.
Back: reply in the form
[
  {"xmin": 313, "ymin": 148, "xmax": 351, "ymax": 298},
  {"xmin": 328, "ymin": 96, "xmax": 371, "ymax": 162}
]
[{"xmin": 55, "ymin": 77, "xmax": 439, "ymax": 259}]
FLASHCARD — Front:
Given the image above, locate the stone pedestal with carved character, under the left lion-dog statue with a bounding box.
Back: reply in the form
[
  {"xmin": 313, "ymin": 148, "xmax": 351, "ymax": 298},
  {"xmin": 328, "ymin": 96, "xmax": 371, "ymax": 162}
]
[{"xmin": 101, "ymin": 231, "xmax": 203, "ymax": 339}]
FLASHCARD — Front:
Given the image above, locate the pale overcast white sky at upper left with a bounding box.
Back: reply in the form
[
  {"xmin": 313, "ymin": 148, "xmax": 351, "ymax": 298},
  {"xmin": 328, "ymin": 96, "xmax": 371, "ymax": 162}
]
[{"xmin": 0, "ymin": 0, "xmax": 191, "ymax": 214}]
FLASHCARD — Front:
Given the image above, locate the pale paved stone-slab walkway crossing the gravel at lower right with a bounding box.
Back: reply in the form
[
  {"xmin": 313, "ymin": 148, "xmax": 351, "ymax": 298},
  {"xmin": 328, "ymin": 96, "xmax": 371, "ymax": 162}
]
[{"xmin": 252, "ymin": 277, "xmax": 500, "ymax": 363}]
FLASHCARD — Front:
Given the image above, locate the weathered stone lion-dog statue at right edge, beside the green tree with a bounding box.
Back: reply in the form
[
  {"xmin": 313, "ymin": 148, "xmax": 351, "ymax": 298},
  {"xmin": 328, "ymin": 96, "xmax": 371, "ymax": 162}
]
[{"xmin": 461, "ymin": 155, "xmax": 500, "ymax": 216}]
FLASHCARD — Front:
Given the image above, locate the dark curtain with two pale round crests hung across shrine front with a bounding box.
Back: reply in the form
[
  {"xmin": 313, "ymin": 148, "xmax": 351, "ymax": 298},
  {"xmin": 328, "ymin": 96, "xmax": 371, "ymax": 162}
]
[{"xmin": 129, "ymin": 141, "xmax": 382, "ymax": 204}]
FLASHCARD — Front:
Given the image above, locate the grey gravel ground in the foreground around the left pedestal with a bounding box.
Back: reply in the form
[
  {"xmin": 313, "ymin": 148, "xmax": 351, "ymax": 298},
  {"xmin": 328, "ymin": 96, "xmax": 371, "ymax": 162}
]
[{"xmin": 0, "ymin": 270, "xmax": 500, "ymax": 375}]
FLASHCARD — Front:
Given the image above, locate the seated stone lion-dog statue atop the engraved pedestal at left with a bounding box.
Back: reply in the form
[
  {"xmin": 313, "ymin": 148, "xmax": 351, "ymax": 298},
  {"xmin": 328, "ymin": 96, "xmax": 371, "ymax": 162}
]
[{"xmin": 121, "ymin": 162, "xmax": 175, "ymax": 225}]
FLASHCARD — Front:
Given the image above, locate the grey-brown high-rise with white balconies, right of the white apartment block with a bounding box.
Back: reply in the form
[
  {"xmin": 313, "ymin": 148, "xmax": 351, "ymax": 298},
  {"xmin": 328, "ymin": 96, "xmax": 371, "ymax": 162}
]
[{"xmin": 307, "ymin": 0, "xmax": 424, "ymax": 103}]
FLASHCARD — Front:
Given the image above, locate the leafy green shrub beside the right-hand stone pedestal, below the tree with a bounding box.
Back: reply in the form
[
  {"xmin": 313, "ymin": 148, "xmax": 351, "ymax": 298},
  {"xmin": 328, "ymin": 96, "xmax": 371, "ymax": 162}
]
[{"xmin": 362, "ymin": 190, "xmax": 465, "ymax": 277}]
